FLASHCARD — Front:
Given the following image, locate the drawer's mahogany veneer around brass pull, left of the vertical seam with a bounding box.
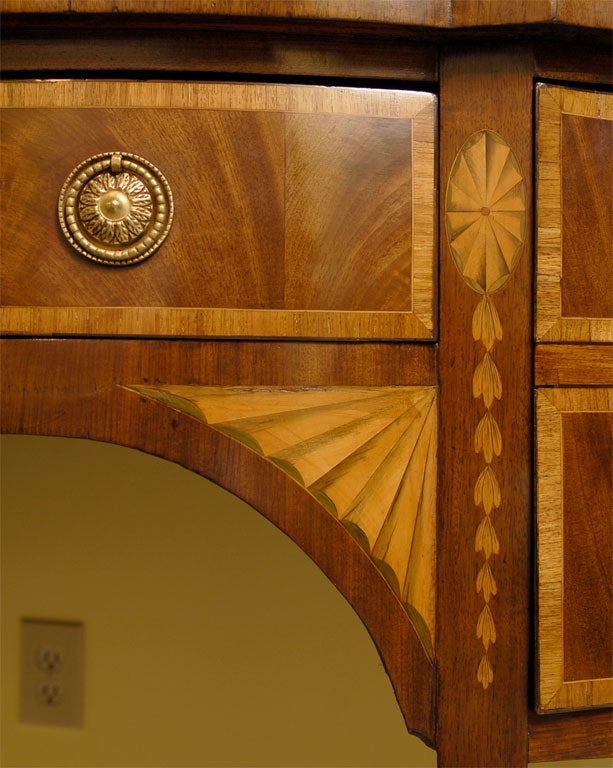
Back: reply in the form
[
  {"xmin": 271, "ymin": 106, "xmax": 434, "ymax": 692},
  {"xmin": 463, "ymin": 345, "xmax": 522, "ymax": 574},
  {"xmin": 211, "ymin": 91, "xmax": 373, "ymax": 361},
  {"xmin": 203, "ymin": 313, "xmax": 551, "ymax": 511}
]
[{"xmin": 1, "ymin": 108, "xmax": 284, "ymax": 308}]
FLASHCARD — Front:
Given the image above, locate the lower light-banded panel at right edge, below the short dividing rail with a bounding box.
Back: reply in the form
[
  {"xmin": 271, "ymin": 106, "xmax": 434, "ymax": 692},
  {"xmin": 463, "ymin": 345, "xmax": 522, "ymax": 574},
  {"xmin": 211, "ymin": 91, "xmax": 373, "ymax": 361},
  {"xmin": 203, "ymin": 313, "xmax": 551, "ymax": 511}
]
[{"xmin": 536, "ymin": 388, "xmax": 613, "ymax": 711}]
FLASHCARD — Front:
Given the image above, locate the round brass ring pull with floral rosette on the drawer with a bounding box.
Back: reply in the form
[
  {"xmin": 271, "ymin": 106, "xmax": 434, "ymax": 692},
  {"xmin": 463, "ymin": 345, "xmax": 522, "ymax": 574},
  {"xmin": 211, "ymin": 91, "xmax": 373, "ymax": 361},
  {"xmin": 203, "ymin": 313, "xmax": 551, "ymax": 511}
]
[{"xmin": 58, "ymin": 152, "xmax": 174, "ymax": 266}]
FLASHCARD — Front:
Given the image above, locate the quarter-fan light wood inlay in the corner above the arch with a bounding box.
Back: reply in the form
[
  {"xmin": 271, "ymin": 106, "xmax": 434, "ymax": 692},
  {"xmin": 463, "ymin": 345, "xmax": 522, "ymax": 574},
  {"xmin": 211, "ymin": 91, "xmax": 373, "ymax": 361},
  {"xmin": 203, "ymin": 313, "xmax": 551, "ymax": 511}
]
[{"xmin": 131, "ymin": 385, "xmax": 437, "ymax": 657}]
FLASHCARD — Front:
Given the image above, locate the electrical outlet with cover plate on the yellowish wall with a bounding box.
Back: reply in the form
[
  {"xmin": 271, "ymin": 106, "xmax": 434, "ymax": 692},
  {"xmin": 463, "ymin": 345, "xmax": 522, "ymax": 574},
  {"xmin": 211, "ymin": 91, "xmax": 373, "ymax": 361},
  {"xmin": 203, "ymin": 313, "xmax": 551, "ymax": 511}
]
[{"xmin": 20, "ymin": 619, "xmax": 84, "ymax": 728}]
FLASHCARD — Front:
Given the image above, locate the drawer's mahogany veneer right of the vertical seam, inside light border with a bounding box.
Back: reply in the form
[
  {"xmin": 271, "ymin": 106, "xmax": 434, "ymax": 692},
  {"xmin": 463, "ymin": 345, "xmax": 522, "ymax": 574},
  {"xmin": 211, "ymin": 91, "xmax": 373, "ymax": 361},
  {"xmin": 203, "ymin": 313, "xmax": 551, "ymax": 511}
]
[{"xmin": 286, "ymin": 115, "xmax": 413, "ymax": 310}]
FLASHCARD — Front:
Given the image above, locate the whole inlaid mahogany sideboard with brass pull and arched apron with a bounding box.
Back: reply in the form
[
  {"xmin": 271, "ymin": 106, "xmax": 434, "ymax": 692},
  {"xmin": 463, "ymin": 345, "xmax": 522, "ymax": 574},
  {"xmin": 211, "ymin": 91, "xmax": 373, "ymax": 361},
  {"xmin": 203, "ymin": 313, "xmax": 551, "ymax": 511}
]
[{"xmin": 0, "ymin": 0, "xmax": 613, "ymax": 766}]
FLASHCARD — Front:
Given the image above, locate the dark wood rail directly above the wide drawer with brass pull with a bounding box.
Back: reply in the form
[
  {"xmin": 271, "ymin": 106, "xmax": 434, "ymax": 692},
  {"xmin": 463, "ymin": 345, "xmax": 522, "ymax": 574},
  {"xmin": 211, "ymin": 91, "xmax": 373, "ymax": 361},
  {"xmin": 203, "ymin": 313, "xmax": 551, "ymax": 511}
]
[{"xmin": 2, "ymin": 27, "xmax": 437, "ymax": 82}]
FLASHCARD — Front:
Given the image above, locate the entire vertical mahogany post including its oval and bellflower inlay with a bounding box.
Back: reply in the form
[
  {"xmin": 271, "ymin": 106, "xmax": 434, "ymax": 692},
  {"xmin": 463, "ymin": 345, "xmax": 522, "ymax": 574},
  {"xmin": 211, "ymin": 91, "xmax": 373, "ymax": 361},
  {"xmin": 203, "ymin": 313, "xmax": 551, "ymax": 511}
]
[{"xmin": 437, "ymin": 46, "xmax": 533, "ymax": 766}]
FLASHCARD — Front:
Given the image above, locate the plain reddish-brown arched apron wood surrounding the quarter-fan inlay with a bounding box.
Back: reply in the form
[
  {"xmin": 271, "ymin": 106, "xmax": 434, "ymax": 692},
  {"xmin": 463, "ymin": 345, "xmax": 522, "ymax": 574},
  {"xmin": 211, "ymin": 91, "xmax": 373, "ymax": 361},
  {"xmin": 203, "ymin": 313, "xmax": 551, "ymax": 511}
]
[{"xmin": 0, "ymin": 339, "xmax": 435, "ymax": 743}]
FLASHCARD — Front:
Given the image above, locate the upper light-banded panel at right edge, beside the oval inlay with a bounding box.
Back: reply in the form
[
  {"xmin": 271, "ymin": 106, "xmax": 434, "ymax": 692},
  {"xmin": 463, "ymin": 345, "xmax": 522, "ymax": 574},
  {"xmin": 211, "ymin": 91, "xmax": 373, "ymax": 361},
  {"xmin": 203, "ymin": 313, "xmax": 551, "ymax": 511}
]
[{"xmin": 536, "ymin": 84, "xmax": 613, "ymax": 342}]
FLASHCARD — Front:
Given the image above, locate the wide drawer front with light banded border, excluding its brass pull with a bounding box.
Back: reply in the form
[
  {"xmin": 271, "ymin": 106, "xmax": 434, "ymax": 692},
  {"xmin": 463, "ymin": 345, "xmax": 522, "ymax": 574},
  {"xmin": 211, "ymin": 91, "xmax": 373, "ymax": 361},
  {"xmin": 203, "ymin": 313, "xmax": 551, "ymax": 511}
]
[{"xmin": 0, "ymin": 81, "xmax": 436, "ymax": 339}]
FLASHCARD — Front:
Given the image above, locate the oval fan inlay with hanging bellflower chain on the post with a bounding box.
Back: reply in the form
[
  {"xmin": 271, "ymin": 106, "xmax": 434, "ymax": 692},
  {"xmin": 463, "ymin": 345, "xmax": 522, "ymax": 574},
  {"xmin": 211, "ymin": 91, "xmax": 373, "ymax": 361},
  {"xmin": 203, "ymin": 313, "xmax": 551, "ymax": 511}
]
[{"xmin": 445, "ymin": 130, "xmax": 526, "ymax": 689}]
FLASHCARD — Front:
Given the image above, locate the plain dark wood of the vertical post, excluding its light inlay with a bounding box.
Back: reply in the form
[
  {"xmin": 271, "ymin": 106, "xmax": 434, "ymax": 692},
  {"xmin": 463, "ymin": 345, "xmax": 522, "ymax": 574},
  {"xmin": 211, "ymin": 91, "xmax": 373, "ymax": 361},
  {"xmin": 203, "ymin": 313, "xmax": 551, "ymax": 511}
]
[{"xmin": 437, "ymin": 47, "xmax": 532, "ymax": 766}]
